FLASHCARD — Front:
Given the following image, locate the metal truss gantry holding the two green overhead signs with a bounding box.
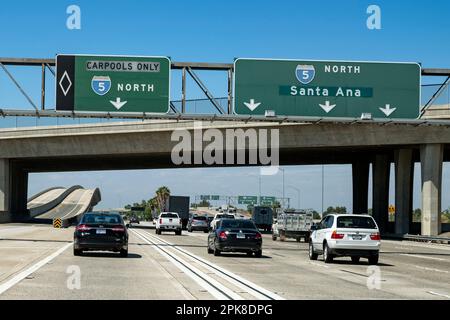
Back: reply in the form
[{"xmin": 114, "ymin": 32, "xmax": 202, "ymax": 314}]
[{"xmin": 0, "ymin": 58, "xmax": 450, "ymax": 121}]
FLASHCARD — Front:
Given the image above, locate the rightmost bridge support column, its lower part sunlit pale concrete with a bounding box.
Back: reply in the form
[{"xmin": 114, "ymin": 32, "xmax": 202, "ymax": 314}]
[{"xmin": 420, "ymin": 144, "xmax": 444, "ymax": 236}]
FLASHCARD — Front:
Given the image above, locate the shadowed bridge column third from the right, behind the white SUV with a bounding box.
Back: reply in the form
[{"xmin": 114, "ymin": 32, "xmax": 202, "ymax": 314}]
[{"xmin": 372, "ymin": 154, "xmax": 391, "ymax": 233}]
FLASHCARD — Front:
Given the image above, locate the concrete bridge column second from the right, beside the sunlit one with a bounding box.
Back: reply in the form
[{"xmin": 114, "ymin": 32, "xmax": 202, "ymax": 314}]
[{"xmin": 395, "ymin": 149, "xmax": 414, "ymax": 234}]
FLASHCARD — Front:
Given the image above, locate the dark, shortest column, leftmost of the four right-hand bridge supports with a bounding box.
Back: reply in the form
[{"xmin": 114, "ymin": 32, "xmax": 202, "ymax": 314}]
[{"xmin": 352, "ymin": 160, "xmax": 369, "ymax": 214}]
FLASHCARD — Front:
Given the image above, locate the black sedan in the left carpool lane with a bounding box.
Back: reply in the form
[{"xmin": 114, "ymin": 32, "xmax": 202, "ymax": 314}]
[{"xmin": 73, "ymin": 212, "xmax": 128, "ymax": 257}]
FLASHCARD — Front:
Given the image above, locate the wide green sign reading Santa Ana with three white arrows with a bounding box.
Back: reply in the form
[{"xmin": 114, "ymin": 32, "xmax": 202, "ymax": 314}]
[{"xmin": 234, "ymin": 58, "xmax": 421, "ymax": 119}]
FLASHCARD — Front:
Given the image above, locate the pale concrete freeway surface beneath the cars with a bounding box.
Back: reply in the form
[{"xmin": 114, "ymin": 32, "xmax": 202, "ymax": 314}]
[{"xmin": 0, "ymin": 224, "xmax": 450, "ymax": 299}]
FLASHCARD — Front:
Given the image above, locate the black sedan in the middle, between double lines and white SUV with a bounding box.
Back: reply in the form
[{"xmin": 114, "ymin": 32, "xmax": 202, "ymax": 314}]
[{"xmin": 208, "ymin": 219, "xmax": 262, "ymax": 258}]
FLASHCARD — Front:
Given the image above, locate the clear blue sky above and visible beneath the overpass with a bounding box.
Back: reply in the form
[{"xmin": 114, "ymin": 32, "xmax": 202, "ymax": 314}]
[{"xmin": 0, "ymin": 0, "xmax": 450, "ymax": 209}]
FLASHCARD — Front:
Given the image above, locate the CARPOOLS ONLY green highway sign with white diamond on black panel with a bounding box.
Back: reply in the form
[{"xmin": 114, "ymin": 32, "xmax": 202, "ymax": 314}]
[{"xmin": 56, "ymin": 55, "xmax": 170, "ymax": 113}]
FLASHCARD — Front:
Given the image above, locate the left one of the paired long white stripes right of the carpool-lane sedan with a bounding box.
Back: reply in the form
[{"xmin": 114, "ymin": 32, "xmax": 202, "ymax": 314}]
[{"xmin": 131, "ymin": 230, "xmax": 244, "ymax": 300}]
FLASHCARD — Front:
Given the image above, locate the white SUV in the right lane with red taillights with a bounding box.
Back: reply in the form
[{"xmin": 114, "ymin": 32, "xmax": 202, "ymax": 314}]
[{"xmin": 309, "ymin": 214, "xmax": 381, "ymax": 264}]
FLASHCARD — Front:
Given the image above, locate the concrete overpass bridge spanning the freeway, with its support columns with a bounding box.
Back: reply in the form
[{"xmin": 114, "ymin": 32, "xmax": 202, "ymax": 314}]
[{"xmin": 0, "ymin": 115, "xmax": 450, "ymax": 235}]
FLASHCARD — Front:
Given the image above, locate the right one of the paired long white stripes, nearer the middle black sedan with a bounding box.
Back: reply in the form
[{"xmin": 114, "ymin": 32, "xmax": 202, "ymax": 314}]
[{"xmin": 144, "ymin": 230, "xmax": 285, "ymax": 300}]
